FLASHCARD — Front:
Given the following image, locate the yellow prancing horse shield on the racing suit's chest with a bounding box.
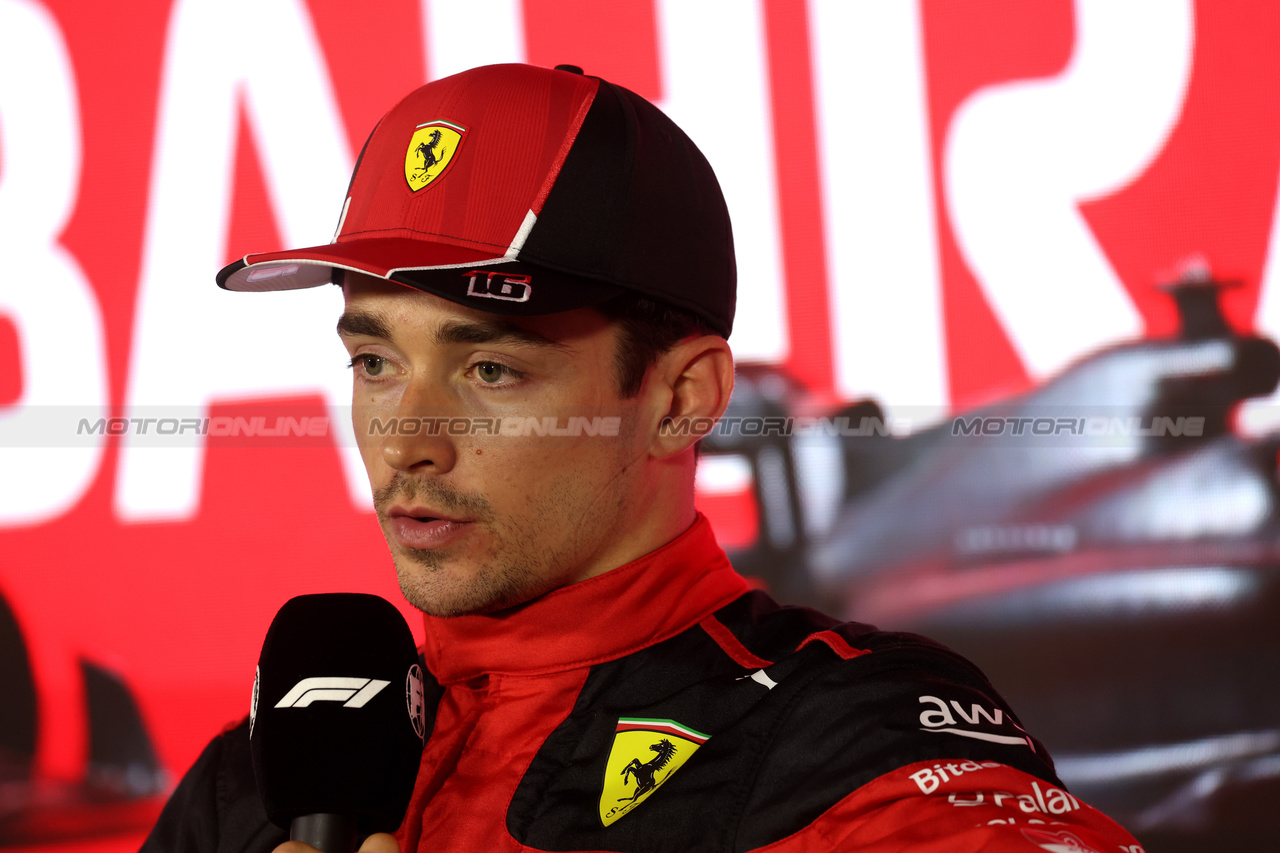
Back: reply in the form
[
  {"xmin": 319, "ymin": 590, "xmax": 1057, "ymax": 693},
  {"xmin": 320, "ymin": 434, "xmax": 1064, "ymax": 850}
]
[{"xmin": 600, "ymin": 717, "xmax": 709, "ymax": 826}]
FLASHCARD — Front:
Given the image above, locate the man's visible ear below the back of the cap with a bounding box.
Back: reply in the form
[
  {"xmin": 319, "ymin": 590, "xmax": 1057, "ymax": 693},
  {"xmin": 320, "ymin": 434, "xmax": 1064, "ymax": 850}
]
[{"xmin": 650, "ymin": 334, "xmax": 733, "ymax": 459}]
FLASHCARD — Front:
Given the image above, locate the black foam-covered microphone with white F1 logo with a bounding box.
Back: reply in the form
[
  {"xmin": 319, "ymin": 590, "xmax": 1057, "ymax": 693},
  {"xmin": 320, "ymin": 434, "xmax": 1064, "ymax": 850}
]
[{"xmin": 250, "ymin": 593, "xmax": 435, "ymax": 853}]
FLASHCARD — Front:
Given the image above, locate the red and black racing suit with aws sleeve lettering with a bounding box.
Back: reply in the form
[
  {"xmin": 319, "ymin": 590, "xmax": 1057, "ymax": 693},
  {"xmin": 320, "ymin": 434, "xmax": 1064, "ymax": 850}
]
[{"xmin": 143, "ymin": 517, "xmax": 1140, "ymax": 853}]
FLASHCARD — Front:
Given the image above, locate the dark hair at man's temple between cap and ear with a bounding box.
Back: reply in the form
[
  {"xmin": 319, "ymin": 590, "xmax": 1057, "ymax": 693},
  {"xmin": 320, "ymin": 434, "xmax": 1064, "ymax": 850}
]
[{"xmin": 596, "ymin": 292, "xmax": 713, "ymax": 397}]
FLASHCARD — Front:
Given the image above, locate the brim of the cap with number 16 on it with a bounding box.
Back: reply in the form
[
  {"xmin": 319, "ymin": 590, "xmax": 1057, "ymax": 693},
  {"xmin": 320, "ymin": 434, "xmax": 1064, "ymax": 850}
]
[{"xmin": 218, "ymin": 237, "xmax": 625, "ymax": 314}]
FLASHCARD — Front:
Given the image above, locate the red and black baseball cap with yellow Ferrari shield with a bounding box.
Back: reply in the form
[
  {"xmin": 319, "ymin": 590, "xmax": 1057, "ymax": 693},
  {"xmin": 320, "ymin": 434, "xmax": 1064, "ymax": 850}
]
[{"xmin": 218, "ymin": 65, "xmax": 737, "ymax": 337}]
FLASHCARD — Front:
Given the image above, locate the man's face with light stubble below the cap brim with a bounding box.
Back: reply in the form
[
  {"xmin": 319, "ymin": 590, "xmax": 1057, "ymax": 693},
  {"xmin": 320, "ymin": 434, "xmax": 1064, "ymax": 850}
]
[{"xmin": 338, "ymin": 275, "xmax": 648, "ymax": 616}]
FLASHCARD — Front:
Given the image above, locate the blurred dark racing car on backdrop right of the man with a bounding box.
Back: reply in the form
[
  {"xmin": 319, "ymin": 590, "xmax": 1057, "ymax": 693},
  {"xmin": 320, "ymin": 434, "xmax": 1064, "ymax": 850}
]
[{"xmin": 704, "ymin": 262, "xmax": 1280, "ymax": 853}]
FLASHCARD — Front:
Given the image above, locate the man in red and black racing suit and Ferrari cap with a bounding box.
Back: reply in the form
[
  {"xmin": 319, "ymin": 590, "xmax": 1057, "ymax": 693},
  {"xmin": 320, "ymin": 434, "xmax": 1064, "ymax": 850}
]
[{"xmin": 148, "ymin": 65, "xmax": 1137, "ymax": 853}]
